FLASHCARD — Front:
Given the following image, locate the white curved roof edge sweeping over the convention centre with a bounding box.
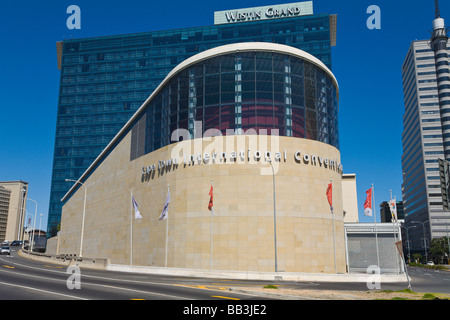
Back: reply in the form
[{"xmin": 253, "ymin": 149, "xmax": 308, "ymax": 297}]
[{"xmin": 61, "ymin": 42, "xmax": 339, "ymax": 201}]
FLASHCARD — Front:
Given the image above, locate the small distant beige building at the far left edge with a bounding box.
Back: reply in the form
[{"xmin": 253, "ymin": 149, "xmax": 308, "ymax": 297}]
[{"xmin": 0, "ymin": 181, "xmax": 28, "ymax": 242}]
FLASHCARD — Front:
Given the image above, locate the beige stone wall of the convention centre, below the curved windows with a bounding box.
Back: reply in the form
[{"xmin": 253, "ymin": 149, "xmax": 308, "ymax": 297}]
[{"xmin": 59, "ymin": 134, "xmax": 346, "ymax": 273}]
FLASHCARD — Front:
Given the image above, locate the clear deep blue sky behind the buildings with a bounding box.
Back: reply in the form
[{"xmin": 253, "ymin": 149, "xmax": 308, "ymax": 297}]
[{"xmin": 0, "ymin": 0, "xmax": 450, "ymax": 228}]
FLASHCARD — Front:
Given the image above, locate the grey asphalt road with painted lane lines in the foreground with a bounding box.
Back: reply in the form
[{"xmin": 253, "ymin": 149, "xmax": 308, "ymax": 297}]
[{"xmin": 0, "ymin": 245, "xmax": 450, "ymax": 306}]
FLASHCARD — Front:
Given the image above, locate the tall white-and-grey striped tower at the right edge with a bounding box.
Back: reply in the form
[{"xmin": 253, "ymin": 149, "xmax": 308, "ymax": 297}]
[{"xmin": 402, "ymin": 2, "xmax": 450, "ymax": 253}]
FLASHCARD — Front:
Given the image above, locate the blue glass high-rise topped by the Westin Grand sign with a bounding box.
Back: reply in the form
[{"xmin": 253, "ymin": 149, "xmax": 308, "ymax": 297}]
[{"xmin": 47, "ymin": 1, "xmax": 337, "ymax": 237}]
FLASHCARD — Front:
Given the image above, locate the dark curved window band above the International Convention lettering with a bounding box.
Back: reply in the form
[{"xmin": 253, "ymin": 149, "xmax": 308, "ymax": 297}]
[{"xmin": 131, "ymin": 51, "xmax": 339, "ymax": 160}]
